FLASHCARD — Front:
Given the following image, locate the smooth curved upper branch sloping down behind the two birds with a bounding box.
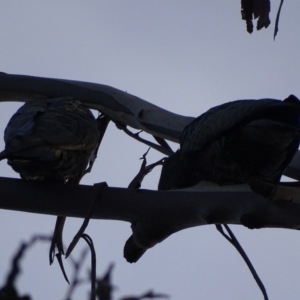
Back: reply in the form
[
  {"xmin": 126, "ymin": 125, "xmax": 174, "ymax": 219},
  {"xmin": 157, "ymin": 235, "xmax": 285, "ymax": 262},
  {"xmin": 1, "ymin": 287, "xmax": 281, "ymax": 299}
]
[{"xmin": 0, "ymin": 73, "xmax": 194, "ymax": 142}]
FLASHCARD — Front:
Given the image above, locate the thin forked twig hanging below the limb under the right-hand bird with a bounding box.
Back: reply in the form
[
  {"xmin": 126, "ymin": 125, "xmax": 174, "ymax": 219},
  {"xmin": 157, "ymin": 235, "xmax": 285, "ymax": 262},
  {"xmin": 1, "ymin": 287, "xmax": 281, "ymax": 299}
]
[{"xmin": 216, "ymin": 224, "xmax": 269, "ymax": 300}]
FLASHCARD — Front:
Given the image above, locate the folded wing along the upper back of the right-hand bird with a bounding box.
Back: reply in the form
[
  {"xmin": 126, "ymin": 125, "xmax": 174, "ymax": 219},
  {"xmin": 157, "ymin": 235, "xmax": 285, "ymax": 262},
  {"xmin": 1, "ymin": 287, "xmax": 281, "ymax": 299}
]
[{"xmin": 180, "ymin": 96, "xmax": 300, "ymax": 152}]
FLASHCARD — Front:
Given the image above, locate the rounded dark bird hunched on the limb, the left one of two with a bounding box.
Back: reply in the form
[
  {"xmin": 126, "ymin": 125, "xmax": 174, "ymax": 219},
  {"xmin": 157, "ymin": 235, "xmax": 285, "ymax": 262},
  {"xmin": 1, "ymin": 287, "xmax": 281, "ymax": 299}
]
[{"xmin": 0, "ymin": 98, "xmax": 99, "ymax": 262}]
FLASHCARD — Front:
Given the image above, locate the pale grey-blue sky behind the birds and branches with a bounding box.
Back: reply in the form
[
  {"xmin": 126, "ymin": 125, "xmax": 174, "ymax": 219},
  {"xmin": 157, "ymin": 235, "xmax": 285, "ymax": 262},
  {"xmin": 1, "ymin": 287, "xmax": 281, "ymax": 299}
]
[{"xmin": 0, "ymin": 0, "xmax": 300, "ymax": 300}]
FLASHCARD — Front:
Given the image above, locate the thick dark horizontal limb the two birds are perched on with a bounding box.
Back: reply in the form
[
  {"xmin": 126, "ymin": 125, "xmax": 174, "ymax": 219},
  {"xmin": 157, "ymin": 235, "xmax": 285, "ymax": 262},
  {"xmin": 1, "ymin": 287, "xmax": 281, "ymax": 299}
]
[{"xmin": 0, "ymin": 178, "xmax": 300, "ymax": 252}]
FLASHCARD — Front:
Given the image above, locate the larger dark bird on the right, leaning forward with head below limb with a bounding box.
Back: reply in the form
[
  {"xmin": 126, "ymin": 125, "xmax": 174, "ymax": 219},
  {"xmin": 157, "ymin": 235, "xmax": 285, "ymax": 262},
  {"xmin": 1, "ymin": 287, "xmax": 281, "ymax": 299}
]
[{"xmin": 124, "ymin": 95, "xmax": 300, "ymax": 262}]
